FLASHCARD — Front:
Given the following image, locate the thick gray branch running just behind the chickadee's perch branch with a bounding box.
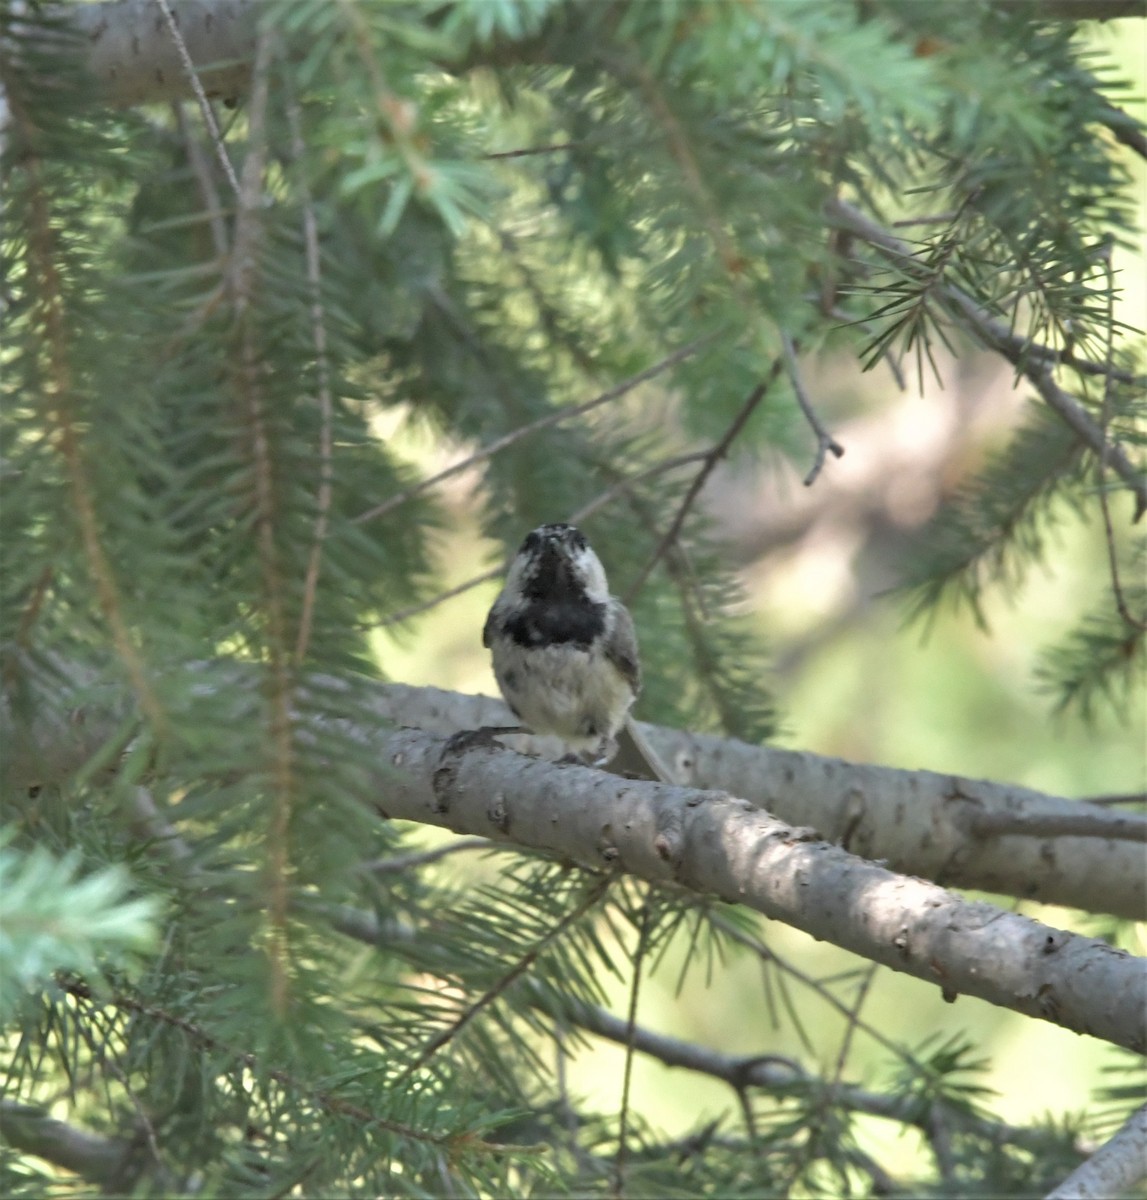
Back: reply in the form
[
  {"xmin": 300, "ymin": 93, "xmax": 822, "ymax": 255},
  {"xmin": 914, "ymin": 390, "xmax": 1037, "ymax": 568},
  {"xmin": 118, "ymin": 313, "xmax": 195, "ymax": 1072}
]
[{"xmin": 0, "ymin": 679, "xmax": 1147, "ymax": 920}]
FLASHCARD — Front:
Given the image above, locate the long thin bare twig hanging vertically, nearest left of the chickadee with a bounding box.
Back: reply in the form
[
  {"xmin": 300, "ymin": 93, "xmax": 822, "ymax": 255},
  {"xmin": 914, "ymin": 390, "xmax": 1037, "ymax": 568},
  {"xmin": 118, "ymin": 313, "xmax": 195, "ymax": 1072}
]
[{"xmin": 287, "ymin": 96, "xmax": 334, "ymax": 662}]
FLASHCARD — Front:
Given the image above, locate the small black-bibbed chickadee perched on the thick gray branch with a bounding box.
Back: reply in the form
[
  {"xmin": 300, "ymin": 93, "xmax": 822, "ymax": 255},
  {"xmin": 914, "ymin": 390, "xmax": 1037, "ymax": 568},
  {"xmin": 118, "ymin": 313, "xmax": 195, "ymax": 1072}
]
[{"xmin": 482, "ymin": 524, "xmax": 641, "ymax": 762}]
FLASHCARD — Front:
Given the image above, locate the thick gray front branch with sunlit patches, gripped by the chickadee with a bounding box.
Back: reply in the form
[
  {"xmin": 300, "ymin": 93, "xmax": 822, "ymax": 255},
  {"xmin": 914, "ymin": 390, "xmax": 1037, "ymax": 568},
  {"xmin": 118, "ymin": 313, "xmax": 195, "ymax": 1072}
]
[{"xmin": 377, "ymin": 730, "xmax": 1147, "ymax": 1051}]
